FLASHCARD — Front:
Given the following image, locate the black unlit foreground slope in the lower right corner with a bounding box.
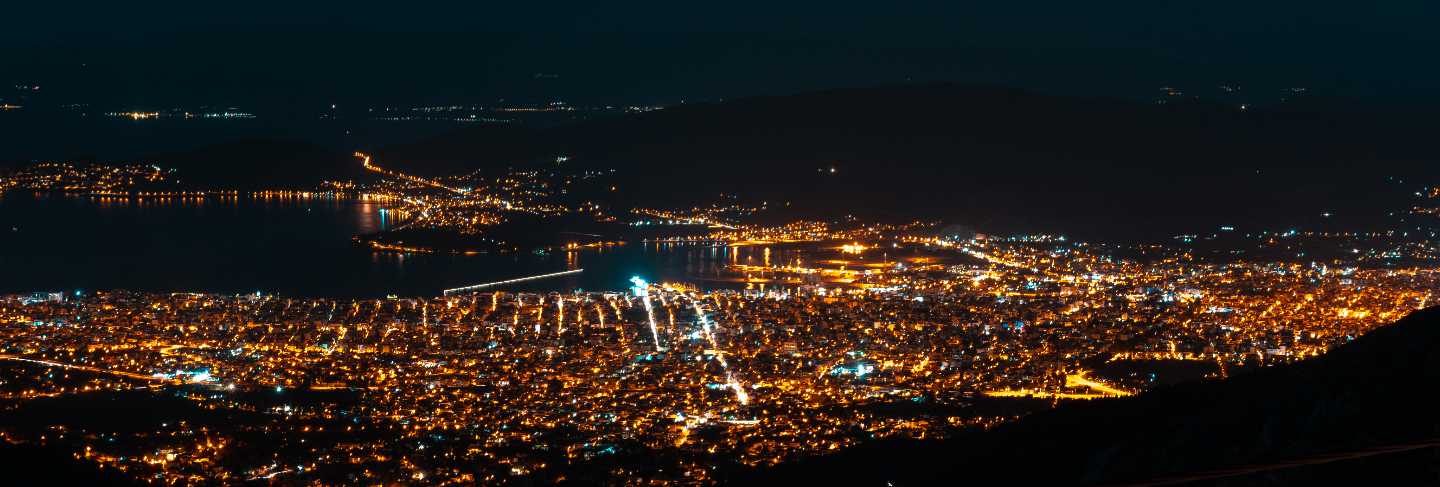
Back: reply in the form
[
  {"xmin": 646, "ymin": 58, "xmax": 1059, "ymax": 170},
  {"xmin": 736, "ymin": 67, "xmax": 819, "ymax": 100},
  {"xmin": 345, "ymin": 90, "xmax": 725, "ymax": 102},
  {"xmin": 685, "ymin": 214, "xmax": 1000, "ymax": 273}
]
[{"xmin": 734, "ymin": 308, "xmax": 1440, "ymax": 486}]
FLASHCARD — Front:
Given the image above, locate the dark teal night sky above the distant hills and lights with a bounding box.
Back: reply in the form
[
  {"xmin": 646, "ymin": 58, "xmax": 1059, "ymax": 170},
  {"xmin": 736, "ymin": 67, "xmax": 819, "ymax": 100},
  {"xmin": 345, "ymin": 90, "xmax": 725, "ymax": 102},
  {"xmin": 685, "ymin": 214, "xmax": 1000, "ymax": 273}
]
[{"xmin": 0, "ymin": 0, "xmax": 1440, "ymax": 105}]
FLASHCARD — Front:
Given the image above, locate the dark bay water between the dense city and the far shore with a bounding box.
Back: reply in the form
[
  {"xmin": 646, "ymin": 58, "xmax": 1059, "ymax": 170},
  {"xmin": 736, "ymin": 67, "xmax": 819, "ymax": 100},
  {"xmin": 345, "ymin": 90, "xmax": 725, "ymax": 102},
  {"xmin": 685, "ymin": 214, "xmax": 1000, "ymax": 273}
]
[{"xmin": 0, "ymin": 193, "xmax": 840, "ymax": 297}]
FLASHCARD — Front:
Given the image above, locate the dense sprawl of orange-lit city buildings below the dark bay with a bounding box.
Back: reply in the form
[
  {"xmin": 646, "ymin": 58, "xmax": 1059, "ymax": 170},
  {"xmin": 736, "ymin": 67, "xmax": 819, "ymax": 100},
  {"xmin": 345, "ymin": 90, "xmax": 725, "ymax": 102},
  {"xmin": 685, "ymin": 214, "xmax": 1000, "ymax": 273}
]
[{"xmin": 0, "ymin": 227, "xmax": 1437, "ymax": 484}]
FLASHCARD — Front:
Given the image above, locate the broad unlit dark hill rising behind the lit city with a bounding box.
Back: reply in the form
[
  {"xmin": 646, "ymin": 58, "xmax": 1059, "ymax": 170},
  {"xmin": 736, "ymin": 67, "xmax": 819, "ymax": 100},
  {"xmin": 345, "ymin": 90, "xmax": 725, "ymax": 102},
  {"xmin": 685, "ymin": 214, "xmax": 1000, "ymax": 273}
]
[{"xmin": 379, "ymin": 85, "xmax": 1434, "ymax": 239}]
